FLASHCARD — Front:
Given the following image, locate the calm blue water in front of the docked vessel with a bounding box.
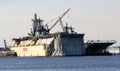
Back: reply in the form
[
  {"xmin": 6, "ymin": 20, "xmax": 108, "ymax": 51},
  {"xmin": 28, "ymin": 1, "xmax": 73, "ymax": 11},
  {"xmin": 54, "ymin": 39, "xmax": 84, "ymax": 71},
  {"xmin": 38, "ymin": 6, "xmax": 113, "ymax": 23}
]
[{"xmin": 0, "ymin": 55, "xmax": 120, "ymax": 71}]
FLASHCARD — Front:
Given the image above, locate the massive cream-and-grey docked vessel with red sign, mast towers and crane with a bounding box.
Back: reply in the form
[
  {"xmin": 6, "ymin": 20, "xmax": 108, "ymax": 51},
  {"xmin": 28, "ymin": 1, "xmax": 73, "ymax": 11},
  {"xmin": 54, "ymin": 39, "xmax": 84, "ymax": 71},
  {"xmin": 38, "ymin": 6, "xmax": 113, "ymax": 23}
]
[{"xmin": 10, "ymin": 8, "xmax": 86, "ymax": 57}]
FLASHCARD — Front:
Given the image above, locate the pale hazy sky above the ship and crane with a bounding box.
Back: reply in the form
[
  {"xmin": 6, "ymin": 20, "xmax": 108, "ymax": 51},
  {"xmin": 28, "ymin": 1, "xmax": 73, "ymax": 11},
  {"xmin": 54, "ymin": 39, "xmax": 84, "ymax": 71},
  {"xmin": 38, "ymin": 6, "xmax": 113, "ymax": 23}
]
[{"xmin": 0, "ymin": 0, "xmax": 120, "ymax": 46}]
